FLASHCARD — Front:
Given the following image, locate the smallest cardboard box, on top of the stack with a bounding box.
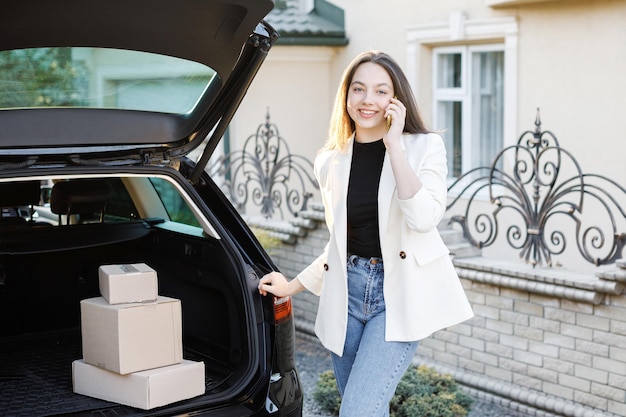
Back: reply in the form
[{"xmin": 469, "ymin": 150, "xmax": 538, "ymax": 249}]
[{"xmin": 98, "ymin": 263, "xmax": 158, "ymax": 304}]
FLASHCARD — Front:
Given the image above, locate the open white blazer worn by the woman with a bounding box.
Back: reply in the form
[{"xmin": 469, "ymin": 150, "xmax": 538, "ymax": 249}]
[{"xmin": 296, "ymin": 133, "xmax": 474, "ymax": 355}]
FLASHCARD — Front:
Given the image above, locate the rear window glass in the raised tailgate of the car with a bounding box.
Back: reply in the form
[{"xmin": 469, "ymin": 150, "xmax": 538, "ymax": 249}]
[{"xmin": 0, "ymin": 48, "xmax": 218, "ymax": 114}]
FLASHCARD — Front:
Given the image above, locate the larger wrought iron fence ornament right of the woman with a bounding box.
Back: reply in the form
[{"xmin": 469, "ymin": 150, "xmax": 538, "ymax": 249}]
[{"xmin": 447, "ymin": 110, "xmax": 626, "ymax": 266}]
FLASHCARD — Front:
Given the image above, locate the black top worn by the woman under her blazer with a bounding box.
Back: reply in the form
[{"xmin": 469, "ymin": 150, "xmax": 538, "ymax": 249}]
[{"xmin": 347, "ymin": 139, "xmax": 385, "ymax": 257}]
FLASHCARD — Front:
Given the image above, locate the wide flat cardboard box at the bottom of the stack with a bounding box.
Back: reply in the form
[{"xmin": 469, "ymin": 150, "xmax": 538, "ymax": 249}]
[{"xmin": 72, "ymin": 360, "xmax": 205, "ymax": 410}]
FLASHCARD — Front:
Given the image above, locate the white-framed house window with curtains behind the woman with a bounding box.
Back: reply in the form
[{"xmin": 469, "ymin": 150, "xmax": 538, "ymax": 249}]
[{"xmin": 433, "ymin": 45, "xmax": 504, "ymax": 177}]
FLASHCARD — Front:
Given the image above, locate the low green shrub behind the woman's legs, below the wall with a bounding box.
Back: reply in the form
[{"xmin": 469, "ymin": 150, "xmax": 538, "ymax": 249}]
[{"xmin": 313, "ymin": 365, "xmax": 473, "ymax": 417}]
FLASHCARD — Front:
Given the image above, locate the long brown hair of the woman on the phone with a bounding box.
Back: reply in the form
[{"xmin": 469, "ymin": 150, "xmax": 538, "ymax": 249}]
[{"xmin": 322, "ymin": 51, "xmax": 429, "ymax": 151}]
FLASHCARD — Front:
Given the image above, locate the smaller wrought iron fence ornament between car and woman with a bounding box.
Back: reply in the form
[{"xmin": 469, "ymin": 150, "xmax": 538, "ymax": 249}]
[{"xmin": 209, "ymin": 109, "xmax": 317, "ymax": 219}]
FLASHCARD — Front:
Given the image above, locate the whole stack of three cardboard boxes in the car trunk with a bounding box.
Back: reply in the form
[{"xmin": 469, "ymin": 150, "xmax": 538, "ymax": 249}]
[{"xmin": 72, "ymin": 264, "xmax": 205, "ymax": 410}]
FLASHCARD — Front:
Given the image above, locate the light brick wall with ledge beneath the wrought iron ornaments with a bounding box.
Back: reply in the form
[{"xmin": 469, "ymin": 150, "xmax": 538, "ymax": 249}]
[{"xmin": 272, "ymin": 214, "xmax": 626, "ymax": 417}]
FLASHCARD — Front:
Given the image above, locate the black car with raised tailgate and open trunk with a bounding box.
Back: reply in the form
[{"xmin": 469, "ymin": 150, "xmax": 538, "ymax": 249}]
[{"xmin": 0, "ymin": 0, "xmax": 302, "ymax": 417}]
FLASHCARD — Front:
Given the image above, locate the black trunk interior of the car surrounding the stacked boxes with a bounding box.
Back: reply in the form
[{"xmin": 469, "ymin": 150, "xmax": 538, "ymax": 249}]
[{"xmin": 0, "ymin": 220, "xmax": 254, "ymax": 417}]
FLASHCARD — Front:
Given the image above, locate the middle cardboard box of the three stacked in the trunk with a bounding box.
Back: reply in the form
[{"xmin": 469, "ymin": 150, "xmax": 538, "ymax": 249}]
[{"xmin": 80, "ymin": 297, "xmax": 183, "ymax": 374}]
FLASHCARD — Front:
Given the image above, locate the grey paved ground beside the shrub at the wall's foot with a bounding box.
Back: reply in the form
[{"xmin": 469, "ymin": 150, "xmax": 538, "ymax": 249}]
[{"xmin": 296, "ymin": 333, "xmax": 528, "ymax": 417}]
